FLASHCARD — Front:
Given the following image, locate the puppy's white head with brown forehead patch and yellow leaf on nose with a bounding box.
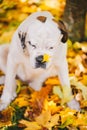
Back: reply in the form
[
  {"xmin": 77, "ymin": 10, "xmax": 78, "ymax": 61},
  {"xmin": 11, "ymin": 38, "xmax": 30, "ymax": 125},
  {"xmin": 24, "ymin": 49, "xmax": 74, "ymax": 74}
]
[{"xmin": 18, "ymin": 11, "xmax": 67, "ymax": 69}]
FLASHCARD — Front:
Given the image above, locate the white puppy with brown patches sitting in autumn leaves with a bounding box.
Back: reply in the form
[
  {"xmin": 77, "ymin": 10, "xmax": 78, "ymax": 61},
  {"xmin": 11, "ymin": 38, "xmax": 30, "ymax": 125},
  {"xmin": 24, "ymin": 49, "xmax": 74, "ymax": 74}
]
[{"xmin": 0, "ymin": 11, "xmax": 79, "ymax": 110}]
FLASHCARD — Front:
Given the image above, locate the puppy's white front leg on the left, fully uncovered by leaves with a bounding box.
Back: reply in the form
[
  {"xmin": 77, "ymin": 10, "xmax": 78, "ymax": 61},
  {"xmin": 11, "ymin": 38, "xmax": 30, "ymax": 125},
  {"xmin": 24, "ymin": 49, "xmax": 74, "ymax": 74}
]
[{"xmin": 0, "ymin": 55, "xmax": 17, "ymax": 110}]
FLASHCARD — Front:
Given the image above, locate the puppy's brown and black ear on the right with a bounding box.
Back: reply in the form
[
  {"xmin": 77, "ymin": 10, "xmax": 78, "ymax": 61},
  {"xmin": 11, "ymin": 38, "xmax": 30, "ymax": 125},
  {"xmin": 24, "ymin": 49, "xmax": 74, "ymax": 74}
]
[{"xmin": 58, "ymin": 20, "xmax": 68, "ymax": 43}]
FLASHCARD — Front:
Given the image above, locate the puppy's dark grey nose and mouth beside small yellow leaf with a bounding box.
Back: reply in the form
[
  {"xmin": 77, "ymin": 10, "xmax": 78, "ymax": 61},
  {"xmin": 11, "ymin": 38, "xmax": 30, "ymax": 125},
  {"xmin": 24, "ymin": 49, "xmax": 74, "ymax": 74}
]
[{"xmin": 35, "ymin": 55, "xmax": 46, "ymax": 69}]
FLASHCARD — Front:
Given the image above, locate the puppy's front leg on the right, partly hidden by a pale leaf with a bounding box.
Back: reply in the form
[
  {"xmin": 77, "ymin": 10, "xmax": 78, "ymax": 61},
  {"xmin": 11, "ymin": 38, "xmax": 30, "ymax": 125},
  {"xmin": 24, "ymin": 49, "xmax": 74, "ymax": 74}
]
[{"xmin": 58, "ymin": 59, "xmax": 80, "ymax": 110}]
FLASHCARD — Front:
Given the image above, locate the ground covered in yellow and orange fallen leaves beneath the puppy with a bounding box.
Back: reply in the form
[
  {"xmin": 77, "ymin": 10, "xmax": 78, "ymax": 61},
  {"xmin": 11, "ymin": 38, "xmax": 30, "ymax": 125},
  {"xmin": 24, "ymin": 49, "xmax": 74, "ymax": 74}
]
[{"xmin": 0, "ymin": 40, "xmax": 87, "ymax": 130}]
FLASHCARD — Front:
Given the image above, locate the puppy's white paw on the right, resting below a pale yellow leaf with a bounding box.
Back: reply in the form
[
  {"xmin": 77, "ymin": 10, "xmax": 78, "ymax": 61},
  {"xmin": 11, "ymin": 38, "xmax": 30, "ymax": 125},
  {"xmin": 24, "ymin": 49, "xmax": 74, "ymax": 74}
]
[{"xmin": 67, "ymin": 99, "xmax": 81, "ymax": 111}]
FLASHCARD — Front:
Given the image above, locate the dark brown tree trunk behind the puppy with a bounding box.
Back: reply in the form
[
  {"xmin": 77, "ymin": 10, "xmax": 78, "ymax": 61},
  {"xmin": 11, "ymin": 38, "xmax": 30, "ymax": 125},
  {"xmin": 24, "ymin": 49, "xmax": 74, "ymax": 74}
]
[{"xmin": 63, "ymin": 0, "xmax": 87, "ymax": 42}]
